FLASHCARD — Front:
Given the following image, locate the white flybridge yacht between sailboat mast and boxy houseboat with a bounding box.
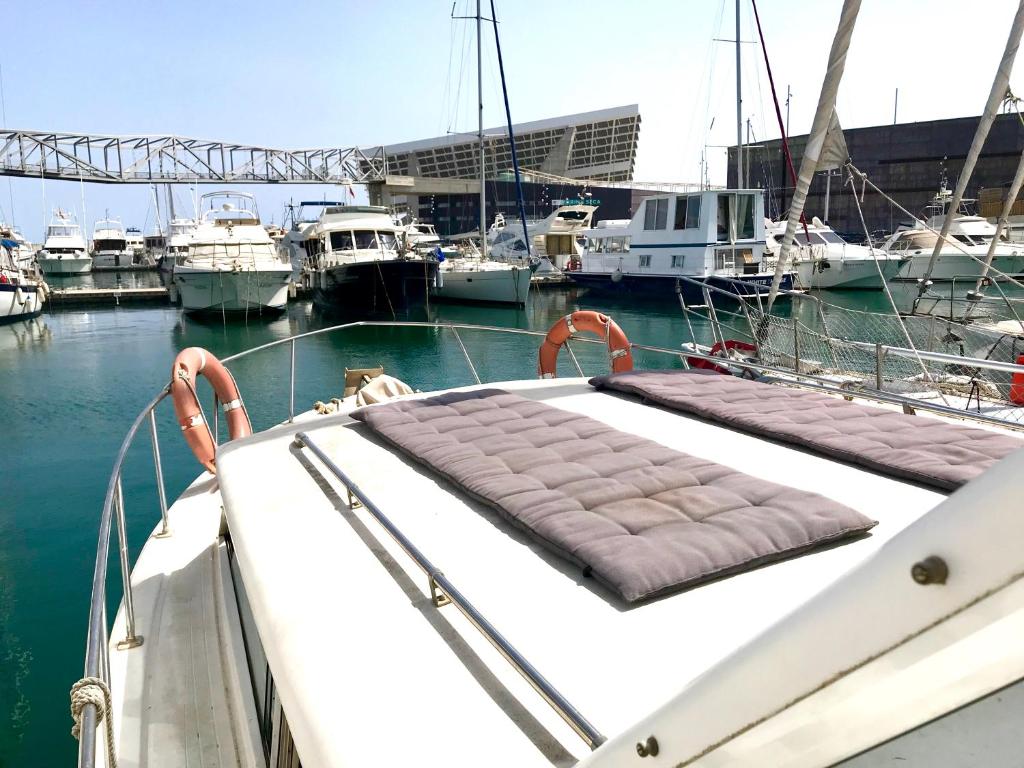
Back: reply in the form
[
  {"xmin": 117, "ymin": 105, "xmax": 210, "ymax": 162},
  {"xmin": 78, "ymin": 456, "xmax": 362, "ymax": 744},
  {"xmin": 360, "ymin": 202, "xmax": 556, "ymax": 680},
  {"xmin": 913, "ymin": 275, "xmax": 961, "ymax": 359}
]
[{"xmin": 487, "ymin": 200, "xmax": 600, "ymax": 275}]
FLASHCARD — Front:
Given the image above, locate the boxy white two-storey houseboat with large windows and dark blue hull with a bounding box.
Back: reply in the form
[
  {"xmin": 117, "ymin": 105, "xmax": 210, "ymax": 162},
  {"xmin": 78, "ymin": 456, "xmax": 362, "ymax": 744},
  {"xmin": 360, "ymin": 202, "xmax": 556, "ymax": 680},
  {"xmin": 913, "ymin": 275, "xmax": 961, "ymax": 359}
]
[{"xmin": 566, "ymin": 189, "xmax": 795, "ymax": 302}]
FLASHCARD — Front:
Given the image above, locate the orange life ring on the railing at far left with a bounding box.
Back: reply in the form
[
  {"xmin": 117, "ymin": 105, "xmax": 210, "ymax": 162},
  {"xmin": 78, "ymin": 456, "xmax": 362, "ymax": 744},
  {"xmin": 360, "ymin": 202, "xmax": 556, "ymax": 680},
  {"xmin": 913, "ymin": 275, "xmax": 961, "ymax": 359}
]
[{"xmin": 171, "ymin": 347, "xmax": 253, "ymax": 473}]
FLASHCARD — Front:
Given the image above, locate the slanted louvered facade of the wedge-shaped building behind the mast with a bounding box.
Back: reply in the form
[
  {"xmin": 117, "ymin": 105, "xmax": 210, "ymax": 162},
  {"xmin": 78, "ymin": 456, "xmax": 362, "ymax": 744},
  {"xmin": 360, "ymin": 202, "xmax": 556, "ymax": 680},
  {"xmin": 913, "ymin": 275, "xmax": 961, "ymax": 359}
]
[{"xmin": 384, "ymin": 104, "xmax": 640, "ymax": 181}]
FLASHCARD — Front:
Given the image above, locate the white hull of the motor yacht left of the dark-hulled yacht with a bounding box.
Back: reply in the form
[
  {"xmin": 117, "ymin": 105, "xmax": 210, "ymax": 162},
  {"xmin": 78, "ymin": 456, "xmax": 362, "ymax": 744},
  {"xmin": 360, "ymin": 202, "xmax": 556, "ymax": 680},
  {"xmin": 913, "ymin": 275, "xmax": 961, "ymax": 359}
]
[{"xmin": 174, "ymin": 265, "xmax": 292, "ymax": 313}]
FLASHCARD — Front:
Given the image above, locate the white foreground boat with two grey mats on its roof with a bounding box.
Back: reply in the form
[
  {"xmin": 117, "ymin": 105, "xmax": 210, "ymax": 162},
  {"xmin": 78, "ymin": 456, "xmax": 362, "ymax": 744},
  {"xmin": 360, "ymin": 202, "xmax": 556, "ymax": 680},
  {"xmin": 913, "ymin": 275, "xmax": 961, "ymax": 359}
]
[{"xmin": 73, "ymin": 312, "xmax": 1024, "ymax": 768}]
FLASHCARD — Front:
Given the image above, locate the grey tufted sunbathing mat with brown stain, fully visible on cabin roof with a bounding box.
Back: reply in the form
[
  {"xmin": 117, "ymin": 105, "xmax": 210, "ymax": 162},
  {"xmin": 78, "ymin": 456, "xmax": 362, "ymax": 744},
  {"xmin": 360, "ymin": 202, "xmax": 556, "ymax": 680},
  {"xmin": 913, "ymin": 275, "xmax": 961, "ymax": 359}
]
[{"xmin": 352, "ymin": 389, "xmax": 874, "ymax": 602}]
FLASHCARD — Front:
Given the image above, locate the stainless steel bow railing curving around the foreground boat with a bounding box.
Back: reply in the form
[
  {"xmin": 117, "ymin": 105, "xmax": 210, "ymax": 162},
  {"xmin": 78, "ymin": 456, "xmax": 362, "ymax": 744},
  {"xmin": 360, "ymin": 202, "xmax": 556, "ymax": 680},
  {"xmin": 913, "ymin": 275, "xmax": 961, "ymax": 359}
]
[{"xmin": 78, "ymin": 319, "xmax": 1024, "ymax": 768}]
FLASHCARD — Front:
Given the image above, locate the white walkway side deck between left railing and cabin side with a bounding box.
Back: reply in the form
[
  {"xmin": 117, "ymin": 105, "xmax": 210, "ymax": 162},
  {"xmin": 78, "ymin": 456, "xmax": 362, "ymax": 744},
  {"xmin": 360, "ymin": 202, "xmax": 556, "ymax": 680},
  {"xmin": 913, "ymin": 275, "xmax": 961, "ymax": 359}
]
[{"xmin": 107, "ymin": 473, "xmax": 264, "ymax": 768}]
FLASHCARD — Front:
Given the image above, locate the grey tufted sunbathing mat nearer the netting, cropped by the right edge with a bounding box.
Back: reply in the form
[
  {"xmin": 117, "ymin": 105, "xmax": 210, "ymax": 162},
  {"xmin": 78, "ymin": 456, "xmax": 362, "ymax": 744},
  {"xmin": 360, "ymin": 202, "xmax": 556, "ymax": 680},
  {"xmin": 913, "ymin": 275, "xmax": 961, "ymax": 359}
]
[{"xmin": 590, "ymin": 371, "xmax": 1024, "ymax": 490}]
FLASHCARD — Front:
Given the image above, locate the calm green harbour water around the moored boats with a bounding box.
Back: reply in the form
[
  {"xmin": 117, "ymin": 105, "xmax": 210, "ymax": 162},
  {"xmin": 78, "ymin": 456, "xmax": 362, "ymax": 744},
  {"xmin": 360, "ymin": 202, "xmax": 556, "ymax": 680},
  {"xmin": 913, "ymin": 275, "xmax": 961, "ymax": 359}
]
[{"xmin": 0, "ymin": 273, "xmax": 929, "ymax": 766}]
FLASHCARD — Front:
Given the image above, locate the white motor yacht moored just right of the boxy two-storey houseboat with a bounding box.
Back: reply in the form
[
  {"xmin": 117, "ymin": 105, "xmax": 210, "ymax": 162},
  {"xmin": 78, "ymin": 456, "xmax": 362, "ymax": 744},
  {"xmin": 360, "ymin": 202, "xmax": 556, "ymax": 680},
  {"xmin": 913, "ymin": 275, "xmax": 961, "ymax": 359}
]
[{"xmin": 765, "ymin": 216, "xmax": 906, "ymax": 291}]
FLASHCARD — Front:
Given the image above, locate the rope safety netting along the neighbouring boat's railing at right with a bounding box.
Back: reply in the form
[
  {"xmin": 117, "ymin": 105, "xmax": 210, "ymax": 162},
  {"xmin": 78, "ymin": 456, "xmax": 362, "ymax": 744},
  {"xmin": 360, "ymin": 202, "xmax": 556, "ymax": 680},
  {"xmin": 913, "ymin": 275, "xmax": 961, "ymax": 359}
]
[{"xmin": 746, "ymin": 299, "xmax": 1024, "ymax": 422}]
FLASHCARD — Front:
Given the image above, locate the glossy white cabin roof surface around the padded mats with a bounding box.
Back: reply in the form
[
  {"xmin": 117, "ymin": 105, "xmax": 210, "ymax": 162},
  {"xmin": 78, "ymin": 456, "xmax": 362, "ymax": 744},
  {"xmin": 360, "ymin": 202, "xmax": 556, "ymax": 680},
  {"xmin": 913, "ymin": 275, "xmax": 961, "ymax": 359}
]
[{"xmin": 216, "ymin": 379, "xmax": 944, "ymax": 768}]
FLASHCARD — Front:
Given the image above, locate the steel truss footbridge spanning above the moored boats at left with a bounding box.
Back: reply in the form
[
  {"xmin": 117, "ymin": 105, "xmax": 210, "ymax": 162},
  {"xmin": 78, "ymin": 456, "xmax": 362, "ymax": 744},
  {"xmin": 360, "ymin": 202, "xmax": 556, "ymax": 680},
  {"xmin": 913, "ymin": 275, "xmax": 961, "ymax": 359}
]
[{"xmin": 0, "ymin": 129, "xmax": 387, "ymax": 184}]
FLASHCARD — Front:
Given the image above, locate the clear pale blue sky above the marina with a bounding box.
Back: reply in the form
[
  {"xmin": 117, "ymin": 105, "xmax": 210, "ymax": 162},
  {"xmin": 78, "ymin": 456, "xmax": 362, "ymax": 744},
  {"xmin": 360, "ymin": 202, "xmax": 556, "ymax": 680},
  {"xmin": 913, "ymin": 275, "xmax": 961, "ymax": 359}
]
[{"xmin": 0, "ymin": 0, "xmax": 1024, "ymax": 240}]
